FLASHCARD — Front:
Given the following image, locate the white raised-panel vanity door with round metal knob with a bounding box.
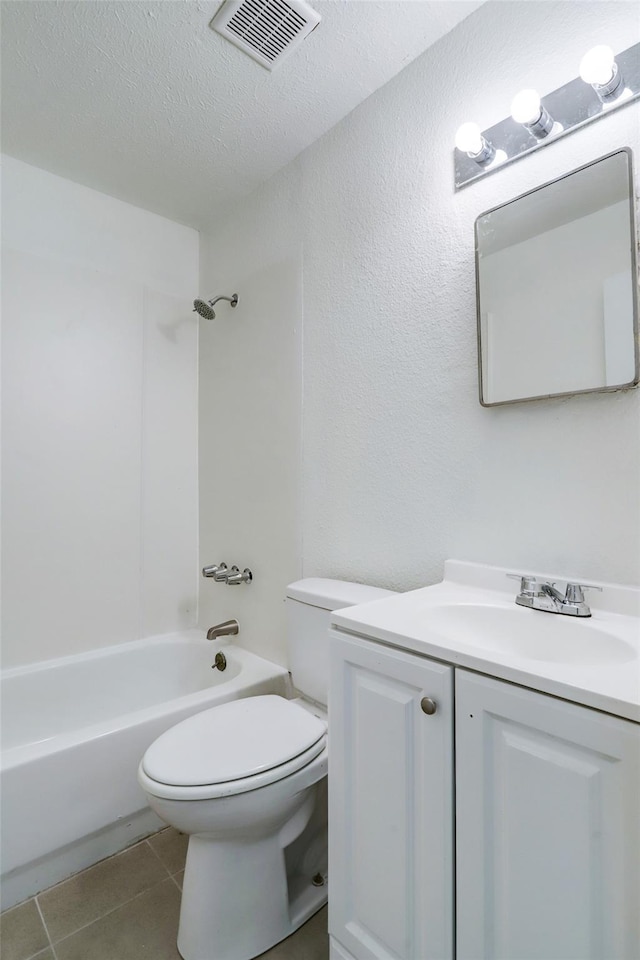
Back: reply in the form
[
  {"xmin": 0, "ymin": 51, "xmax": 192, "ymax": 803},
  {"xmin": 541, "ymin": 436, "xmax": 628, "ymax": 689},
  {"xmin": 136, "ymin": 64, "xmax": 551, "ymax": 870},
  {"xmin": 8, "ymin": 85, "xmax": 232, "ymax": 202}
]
[{"xmin": 329, "ymin": 632, "xmax": 453, "ymax": 960}]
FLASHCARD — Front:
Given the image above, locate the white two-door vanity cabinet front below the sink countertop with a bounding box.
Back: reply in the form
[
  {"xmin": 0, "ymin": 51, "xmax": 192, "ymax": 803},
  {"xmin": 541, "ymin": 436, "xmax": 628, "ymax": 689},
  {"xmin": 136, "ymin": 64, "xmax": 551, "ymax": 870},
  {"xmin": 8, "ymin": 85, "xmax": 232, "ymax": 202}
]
[{"xmin": 329, "ymin": 631, "xmax": 640, "ymax": 960}]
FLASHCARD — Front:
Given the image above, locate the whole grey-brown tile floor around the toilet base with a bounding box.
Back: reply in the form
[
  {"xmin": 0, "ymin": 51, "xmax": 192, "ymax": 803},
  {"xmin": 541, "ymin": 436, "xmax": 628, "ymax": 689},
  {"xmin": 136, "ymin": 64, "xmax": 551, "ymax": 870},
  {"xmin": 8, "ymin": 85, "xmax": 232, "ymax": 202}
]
[{"xmin": 0, "ymin": 827, "xmax": 329, "ymax": 960}]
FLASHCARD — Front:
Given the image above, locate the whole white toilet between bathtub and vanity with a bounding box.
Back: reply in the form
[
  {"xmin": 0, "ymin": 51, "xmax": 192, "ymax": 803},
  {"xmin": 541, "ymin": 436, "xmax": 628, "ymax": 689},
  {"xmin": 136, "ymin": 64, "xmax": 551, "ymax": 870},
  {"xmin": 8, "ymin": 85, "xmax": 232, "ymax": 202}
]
[{"xmin": 138, "ymin": 578, "xmax": 390, "ymax": 960}]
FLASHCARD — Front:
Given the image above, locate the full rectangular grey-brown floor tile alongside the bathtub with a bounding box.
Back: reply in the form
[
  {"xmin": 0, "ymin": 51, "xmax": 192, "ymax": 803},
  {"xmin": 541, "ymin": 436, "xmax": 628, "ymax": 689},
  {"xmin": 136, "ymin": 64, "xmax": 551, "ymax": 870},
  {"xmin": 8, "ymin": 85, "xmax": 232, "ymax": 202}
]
[{"xmin": 37, "ymin": 842, "xmax": 168, "ymax": 940}]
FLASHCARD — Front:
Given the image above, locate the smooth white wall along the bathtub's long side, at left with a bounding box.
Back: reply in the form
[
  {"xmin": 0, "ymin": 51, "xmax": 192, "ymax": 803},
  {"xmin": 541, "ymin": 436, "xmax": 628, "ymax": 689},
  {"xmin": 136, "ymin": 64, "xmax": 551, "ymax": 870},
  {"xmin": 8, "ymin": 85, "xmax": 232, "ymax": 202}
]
[{"xmin": 2, "ymin": 157, "xmax": 198, "ymax": 666}]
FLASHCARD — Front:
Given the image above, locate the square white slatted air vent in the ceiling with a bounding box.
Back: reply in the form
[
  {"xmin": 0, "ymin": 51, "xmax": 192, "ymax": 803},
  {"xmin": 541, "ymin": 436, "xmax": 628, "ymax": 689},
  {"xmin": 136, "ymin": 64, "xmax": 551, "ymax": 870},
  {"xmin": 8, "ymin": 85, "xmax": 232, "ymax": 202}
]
[{"xmin": 210, "ymin": 0, "xmax": 321, "ymax": 70}]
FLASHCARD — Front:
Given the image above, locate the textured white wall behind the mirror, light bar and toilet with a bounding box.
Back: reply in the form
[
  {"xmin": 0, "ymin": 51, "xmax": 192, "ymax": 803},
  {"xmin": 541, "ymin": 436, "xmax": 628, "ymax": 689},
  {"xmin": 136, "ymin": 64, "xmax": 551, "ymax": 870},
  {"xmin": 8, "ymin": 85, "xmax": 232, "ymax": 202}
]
[{"xmin": 200, "ymin": 2, "xmax": 640, "ymax": 659}]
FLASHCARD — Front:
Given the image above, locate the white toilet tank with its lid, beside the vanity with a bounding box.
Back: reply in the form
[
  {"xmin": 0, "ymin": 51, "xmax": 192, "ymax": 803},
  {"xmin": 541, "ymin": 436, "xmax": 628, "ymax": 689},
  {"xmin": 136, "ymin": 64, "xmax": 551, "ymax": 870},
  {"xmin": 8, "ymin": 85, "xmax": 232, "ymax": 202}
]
[{"xmin": 286, "ymin": 577, "xmax": 394, "ymax": 704}]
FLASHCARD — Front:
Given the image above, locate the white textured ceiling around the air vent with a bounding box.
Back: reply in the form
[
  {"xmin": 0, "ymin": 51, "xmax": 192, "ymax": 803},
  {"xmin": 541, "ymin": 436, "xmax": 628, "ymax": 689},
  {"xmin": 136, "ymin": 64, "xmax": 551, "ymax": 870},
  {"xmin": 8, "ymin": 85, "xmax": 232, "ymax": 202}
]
[{"xmin": 2, "ymin": 0, "xmax": 480, "ymax": 227}]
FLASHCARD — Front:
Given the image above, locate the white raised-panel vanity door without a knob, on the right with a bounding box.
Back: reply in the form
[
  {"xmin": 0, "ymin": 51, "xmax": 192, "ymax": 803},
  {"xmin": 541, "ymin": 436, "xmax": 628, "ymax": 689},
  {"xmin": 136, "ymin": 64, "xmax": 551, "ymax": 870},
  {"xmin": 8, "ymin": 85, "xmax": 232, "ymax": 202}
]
[{"xmin": 456, "ymin": 670, "xmax": 640, "ymax": 960}]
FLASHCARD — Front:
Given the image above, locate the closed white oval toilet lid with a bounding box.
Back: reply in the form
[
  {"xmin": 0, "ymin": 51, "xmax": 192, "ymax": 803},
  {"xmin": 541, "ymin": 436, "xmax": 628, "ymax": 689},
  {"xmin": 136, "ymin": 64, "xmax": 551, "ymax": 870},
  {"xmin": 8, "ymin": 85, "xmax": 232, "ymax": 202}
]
[{"xmin": 142, "ymin": 695, "xmax": 327, "ymax": 786}]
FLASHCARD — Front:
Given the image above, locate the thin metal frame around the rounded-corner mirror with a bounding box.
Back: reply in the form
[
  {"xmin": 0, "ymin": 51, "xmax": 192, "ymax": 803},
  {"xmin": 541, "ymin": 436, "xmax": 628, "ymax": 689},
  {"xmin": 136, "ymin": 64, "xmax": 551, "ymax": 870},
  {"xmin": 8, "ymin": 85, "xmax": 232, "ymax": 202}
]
[{"xmin": 474, "ymin": 147, "xmax": 640, "ymax": 407}]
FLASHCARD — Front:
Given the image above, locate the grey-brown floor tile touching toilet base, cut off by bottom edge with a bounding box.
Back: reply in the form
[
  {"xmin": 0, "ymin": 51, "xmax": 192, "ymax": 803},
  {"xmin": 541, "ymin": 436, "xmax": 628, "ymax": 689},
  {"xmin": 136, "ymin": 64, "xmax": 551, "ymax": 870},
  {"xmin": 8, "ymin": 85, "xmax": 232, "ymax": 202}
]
[{"xmin": 56, "ymin": 879, "xmax": 180, "ymax": 960}]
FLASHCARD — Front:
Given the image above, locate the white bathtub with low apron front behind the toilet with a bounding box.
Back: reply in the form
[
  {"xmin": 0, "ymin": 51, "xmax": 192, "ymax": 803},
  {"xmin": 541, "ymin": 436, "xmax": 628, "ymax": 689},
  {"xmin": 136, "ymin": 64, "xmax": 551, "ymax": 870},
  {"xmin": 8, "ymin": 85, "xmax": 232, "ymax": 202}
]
[{"xmin": 0, "ymin": 630, "xmax": 289, "ymax": 909}]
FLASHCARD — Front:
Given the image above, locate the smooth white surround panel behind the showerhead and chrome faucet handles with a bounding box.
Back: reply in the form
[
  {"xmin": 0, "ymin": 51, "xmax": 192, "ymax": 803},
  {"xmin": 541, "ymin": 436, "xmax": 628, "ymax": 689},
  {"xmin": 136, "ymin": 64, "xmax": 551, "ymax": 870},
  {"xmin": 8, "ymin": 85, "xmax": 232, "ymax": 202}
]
[{"xmin": 198, "ymin": 248, "xmax": 303, "ymax": 665}]
